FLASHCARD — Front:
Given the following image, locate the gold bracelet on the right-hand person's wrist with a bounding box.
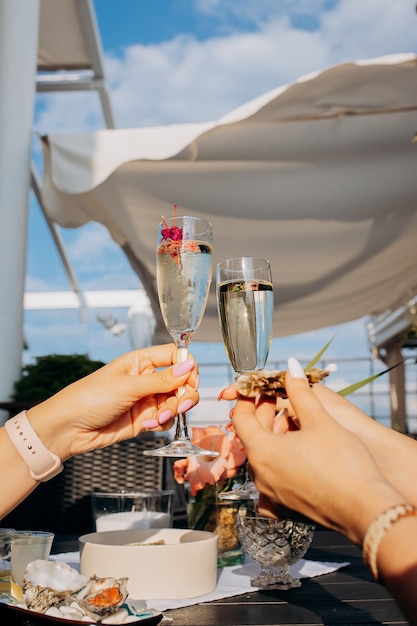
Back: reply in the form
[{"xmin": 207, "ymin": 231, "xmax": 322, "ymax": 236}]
[{"xmin": 363, "ymin": 503, "xmax": 417, "ymax": 580}]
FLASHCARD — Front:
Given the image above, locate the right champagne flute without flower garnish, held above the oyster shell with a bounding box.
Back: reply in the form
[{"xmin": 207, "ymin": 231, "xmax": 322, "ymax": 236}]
[{"xmin": 217, "ymin": 257, "xmax": 274, "ymax": 500}]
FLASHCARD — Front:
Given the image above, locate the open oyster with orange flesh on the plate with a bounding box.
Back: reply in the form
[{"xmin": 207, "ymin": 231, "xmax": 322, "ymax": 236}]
[{"xmin": 76, "ymin": 576, "xmax": 128, "ymax": 618}]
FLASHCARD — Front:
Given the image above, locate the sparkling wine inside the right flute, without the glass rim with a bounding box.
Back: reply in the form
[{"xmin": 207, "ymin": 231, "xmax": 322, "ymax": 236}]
[{"xmin": 218, "ymin": 281, "xmax": 274, "ymax": 372}]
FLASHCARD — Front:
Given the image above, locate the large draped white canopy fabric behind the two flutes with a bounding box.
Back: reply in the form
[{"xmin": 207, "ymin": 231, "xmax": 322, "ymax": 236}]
[{"xmin": 42, "ymin": 54, "xmax": 417, "ymax": 341}]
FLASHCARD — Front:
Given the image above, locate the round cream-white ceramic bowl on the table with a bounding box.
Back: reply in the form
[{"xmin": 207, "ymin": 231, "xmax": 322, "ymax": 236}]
[{"xmin": 79, "ymin": 528, "xmax": 217, "ymax": 600}]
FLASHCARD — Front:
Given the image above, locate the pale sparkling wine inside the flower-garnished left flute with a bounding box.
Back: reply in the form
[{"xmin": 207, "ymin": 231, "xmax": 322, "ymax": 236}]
[{"xmin": 157, "ymin": 241, "xmax": 212, "ymax": 340}]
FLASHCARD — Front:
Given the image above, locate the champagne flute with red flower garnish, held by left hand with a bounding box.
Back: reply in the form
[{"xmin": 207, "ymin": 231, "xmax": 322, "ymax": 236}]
[{"xmin": 144, "ymin": 216, "xmax": 219, "ymax": 457}]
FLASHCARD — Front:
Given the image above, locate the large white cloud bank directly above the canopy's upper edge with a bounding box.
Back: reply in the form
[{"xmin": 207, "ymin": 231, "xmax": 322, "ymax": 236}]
[{"xmin": 108, "ymin": 0, "xmax": 415, "ymax": 126}]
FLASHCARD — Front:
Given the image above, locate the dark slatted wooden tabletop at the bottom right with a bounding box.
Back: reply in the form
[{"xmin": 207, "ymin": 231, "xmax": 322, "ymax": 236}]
[{"xmin": 55, "ymin": 530, "xmax": 407, "ymax": 626}]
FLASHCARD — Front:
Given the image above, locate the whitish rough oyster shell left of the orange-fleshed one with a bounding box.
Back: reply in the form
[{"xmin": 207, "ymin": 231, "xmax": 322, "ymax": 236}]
[{"xmin": 22, "ymin": 559, "xmax": 90, "ymax": 613}]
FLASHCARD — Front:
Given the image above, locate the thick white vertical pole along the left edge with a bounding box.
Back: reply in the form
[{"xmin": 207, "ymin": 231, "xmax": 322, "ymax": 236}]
[{"xmin": 0, "ymin": 0, "xmax": 39, "ymax": 421}]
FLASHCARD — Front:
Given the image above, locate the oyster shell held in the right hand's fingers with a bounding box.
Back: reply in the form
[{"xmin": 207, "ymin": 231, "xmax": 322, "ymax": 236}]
[{"xmin": 236, "ymin": 367, "xmax": 333, "ymax": 398}]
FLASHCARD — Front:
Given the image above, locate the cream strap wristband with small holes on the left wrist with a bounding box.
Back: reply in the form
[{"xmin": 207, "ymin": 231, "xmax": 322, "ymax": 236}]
[{"xmin": 4, "ymin": 411, "xmax": 64, "ymax": 482}]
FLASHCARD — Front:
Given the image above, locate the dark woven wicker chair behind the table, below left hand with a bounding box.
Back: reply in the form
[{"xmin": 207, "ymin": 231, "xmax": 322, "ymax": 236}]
[{"xmin": 1, "ymin": 433, "xmax": 173, "ymax": 534}]
